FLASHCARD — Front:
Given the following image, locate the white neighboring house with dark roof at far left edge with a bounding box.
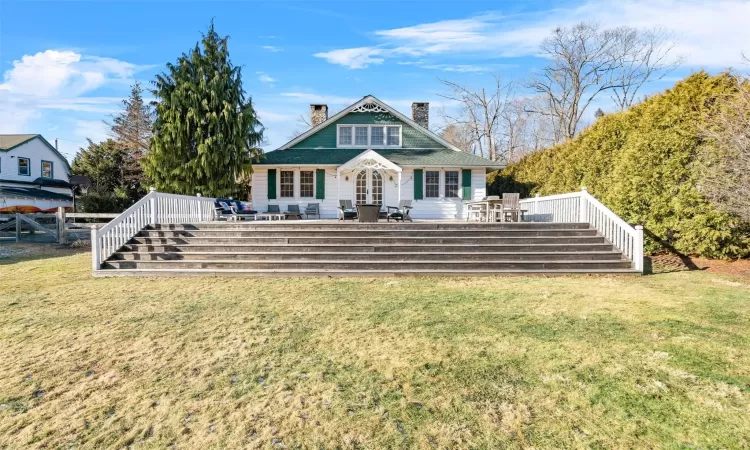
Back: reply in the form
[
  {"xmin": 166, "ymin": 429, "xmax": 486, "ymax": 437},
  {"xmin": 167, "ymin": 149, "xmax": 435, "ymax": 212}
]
[{"xmin": 0, "ymin": 134, "xmax": 73, "ymax": 213}]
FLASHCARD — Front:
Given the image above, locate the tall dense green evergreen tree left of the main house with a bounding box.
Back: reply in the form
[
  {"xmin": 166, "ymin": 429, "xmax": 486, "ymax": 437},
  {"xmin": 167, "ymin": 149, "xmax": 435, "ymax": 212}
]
[{"xmin": 144, "ymin": 21, "xmax": 263, "ymax": 197}]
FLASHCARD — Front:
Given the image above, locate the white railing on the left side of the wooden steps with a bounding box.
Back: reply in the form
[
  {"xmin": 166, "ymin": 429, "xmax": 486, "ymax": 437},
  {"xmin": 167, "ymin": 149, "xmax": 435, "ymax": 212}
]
[{"xmin": 91, "ymin": 189, "xmax": 214, "ymax": 270}]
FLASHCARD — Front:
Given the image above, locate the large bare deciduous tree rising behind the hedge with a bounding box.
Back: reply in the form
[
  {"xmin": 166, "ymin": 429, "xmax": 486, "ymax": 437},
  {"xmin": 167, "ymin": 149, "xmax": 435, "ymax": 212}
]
[{"xmin": 528, "ymin": 23, "xmax": 677, "ymax": 140}]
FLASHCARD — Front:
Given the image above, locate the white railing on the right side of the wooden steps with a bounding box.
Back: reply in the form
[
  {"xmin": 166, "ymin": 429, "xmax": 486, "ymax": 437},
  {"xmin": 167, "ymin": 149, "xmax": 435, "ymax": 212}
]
[{"xmin": 521, "ymin": 188, "xmax": 643, "ymax": 272}]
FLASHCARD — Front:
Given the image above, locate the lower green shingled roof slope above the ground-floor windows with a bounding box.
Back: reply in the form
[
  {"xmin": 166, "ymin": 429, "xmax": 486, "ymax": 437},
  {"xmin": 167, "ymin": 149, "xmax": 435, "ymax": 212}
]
[{"xmin": 255, "ymin": 148, "xmax": 503, "ymax": 168}]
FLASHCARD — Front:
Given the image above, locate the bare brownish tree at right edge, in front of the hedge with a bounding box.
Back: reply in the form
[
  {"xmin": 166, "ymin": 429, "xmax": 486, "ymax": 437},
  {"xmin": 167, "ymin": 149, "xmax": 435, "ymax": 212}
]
[{"xmin": 702, "ymin": 70, "xmax": 750, "ymax": 222}]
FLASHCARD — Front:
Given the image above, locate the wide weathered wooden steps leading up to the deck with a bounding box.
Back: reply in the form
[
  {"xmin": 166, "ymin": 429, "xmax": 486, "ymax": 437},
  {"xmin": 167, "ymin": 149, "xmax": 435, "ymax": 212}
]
[{"xmin": 95, "ymin": 221, "xmax": 637, "ymax": 277}]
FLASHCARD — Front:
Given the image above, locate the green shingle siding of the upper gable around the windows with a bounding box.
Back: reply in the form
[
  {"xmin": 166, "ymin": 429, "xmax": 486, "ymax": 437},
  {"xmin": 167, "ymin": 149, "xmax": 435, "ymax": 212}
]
[{"xmin": 291, "ymin": 113, "xmax": 446, "ymax": 151}]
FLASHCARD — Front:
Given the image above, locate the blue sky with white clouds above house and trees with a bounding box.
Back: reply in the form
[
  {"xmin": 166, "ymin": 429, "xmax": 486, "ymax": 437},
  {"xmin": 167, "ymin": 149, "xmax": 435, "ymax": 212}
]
[{"xmin": 0, "ymin": 0, "xmax": 750, "ymax": 159}]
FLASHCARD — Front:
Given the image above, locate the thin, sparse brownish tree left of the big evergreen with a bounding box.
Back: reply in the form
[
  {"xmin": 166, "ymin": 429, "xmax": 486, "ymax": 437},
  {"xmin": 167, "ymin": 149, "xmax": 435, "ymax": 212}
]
[{"xmin": 107, "ymin": 81, "xmax": 154, "ymax": 192}]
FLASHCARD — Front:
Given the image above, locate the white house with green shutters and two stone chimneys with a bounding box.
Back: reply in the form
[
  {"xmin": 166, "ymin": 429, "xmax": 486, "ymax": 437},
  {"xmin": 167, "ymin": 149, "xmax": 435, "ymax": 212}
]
[{"xmin": 252, "ymin": 95, "xmax": 503, "ymax": 219}]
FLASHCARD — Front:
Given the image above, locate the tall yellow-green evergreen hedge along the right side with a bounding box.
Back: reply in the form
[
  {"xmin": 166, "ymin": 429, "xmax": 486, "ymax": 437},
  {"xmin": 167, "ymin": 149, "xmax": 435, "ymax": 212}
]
[{"xmin": 487, "ymin": 72, "xmax": 750, "ymax": 259}]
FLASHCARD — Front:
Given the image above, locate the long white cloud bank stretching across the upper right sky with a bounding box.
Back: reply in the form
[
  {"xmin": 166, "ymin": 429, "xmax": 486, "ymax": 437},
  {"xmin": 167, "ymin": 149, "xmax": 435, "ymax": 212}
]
[{"xmin": 314, "ymin": 0, "xmax": 750, "ymax": 69}]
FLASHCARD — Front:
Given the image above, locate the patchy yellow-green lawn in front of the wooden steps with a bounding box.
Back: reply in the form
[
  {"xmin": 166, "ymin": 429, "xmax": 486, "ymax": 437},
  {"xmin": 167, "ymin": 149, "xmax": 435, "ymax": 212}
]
[{"xmin": 0, "ymin": 253, "xmax": 750, "ymax": 449}]
